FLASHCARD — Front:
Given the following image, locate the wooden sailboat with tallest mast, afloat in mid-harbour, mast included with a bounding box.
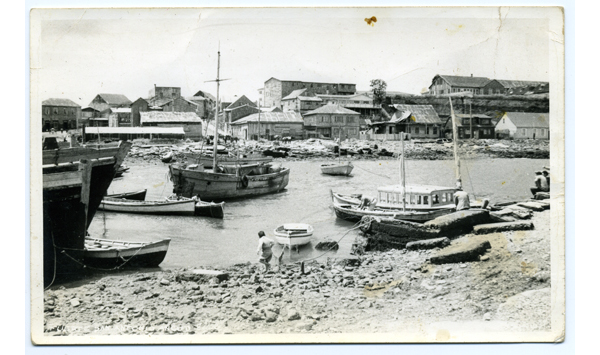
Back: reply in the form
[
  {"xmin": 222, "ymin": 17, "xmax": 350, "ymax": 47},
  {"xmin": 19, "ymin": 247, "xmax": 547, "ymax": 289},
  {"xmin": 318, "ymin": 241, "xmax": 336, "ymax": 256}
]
[{"xmin": 169, "ymin": 51, "xmax": 290, "ymax": 201}]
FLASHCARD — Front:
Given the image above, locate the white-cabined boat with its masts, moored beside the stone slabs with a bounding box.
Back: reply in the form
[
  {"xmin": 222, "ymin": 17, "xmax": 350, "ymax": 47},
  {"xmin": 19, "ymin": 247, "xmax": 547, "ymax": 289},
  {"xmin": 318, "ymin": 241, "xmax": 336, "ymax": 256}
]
[{"xmin": 331, "ymin": 99, "xmax": 462, "ymax": 222}]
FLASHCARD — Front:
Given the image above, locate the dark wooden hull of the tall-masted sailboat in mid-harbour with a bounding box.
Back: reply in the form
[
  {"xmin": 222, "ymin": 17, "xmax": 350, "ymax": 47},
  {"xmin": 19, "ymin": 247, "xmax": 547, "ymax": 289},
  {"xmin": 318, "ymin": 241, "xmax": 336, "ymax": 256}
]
[{"xmin": 169, "ymin": 165, "xmax": 290, "ymax": 201}]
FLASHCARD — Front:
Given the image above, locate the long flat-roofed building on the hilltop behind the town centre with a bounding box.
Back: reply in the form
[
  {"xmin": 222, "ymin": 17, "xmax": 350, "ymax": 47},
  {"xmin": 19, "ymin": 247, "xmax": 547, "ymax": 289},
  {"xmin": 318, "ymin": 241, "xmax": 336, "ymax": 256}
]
[{"xmin": 259, "ymin": 78, "xmax": 356, "ymax": 107}]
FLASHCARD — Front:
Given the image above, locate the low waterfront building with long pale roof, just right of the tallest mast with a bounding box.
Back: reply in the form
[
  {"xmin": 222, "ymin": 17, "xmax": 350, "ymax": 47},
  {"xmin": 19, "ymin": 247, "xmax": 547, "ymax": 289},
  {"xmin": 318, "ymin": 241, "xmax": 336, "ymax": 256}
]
[{"xmin": 231, "ymin": 112, "xmax": 304, "ymax": 140}]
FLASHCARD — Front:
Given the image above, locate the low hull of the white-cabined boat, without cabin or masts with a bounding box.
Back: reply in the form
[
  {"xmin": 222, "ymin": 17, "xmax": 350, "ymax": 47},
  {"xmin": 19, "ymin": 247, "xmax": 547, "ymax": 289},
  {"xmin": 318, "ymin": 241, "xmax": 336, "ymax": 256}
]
[{"xmin": 333, "ymin": 204, "xmax": 454, "ymax": 222}]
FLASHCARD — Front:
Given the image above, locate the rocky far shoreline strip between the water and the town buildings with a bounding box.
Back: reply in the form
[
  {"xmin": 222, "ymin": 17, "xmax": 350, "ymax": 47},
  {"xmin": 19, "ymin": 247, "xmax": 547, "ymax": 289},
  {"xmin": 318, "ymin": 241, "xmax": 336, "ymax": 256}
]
[{"xmin": 120, "ymin": 139, "xmax": 550, "ymax": 167}]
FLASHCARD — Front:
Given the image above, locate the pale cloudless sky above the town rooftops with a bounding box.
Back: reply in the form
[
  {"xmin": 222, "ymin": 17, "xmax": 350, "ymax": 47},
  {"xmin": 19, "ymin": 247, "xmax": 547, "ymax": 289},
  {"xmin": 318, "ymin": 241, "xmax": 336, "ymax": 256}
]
[{"xmin": 30, "ymin": 8, "xmax": 552, "ymax": 107}]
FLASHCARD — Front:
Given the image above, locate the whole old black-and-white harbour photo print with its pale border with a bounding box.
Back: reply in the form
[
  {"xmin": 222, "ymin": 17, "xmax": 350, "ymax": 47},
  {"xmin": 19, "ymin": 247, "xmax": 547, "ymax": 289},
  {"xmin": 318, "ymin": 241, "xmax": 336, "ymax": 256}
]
[{"xmin": 30, "ymin": 7, "xmax": 565, "ymax": 344}]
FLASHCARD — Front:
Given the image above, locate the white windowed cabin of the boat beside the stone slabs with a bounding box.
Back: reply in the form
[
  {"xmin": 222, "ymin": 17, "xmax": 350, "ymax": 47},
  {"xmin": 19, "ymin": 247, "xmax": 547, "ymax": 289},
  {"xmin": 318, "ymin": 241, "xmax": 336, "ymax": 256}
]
[{"xmin": 377, "ymin": 185, "xmax": 456, "ymax": 210}]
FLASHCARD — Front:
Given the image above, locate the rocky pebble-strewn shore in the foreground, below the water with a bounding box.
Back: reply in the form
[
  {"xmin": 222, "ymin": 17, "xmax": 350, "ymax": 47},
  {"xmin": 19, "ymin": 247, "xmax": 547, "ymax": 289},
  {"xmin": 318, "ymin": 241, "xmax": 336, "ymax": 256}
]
[{"xmin": 44, "ymin": 210, "xmax": 550, "ymax": 341}]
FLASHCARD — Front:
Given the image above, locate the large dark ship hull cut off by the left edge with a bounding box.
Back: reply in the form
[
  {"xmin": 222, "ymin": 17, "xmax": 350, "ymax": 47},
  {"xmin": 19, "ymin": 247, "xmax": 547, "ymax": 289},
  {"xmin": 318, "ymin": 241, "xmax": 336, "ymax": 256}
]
[{"xmin": 42, "ymin": 142, "xmax": 131, "ymax": 286}]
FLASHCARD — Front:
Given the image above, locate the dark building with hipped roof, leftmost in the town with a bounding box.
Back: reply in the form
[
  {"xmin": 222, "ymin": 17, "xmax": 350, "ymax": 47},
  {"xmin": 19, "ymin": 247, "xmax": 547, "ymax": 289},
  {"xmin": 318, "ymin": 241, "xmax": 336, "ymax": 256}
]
[{"xmin": 42, "ymin": 98, "xmax": 81, "ymax": 132}]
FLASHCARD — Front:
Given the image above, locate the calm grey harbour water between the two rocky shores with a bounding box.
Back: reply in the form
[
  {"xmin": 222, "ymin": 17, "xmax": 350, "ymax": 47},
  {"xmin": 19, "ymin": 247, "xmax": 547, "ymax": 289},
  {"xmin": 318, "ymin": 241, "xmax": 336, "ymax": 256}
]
[{"xmin": 89, "ymin": 159, "xmax": 549, "ymax": 269}]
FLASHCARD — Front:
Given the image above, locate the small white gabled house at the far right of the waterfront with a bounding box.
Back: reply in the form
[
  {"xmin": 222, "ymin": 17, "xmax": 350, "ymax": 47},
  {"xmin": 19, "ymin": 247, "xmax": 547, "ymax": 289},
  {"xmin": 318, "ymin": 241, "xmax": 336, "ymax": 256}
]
[{"xmin": 495, "ymin": 112, "xmax": 550, "ymax": 139}]
